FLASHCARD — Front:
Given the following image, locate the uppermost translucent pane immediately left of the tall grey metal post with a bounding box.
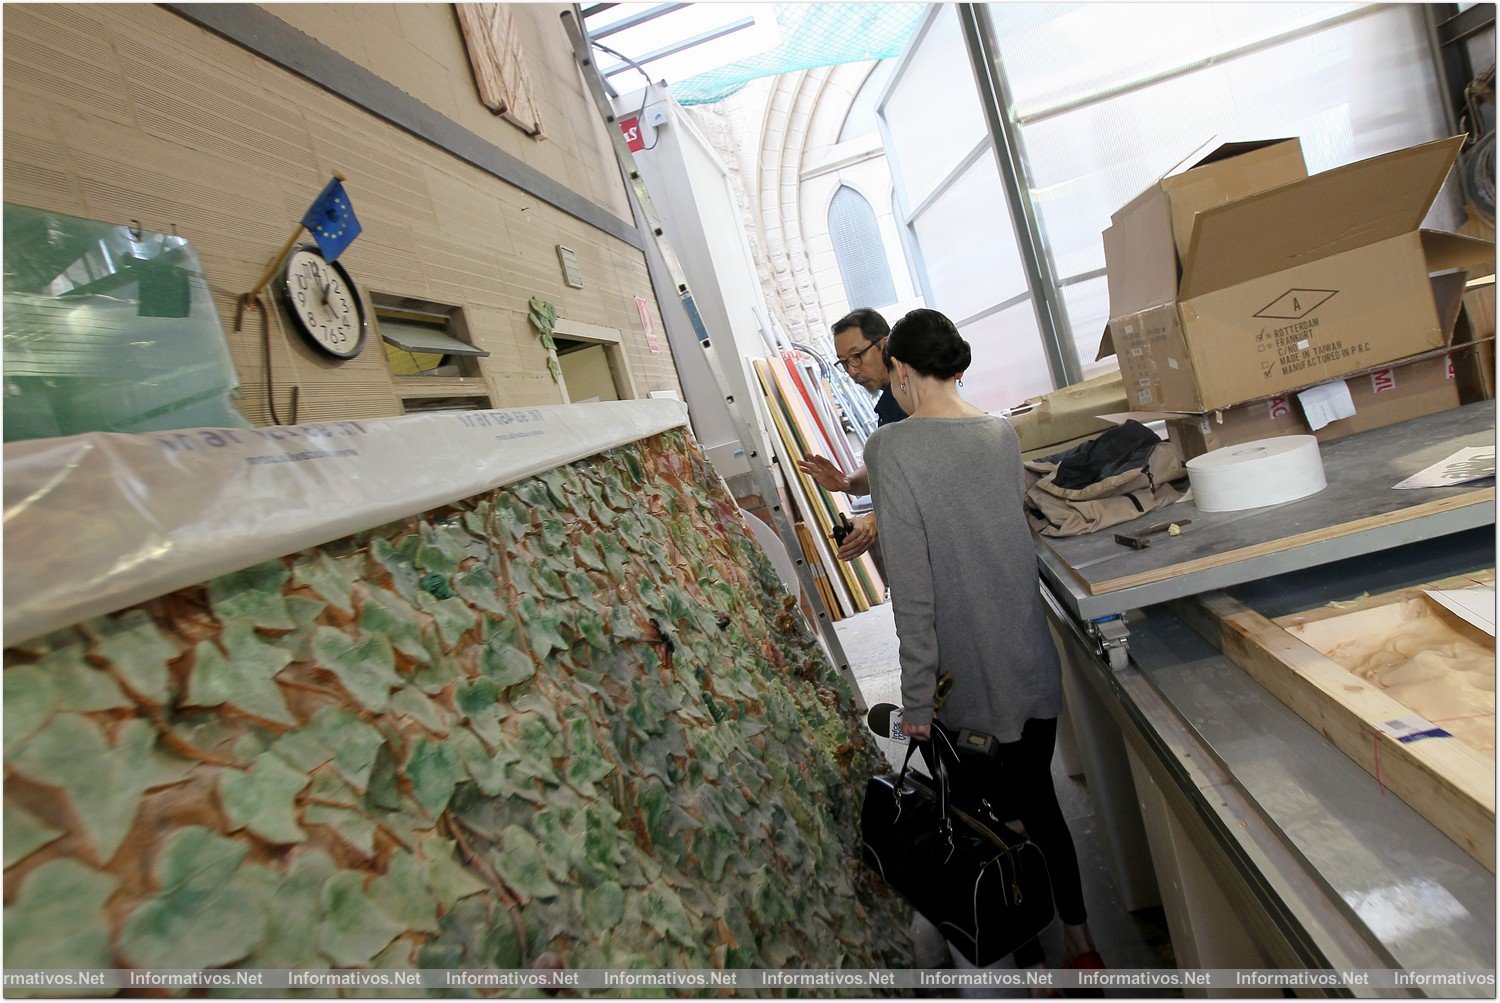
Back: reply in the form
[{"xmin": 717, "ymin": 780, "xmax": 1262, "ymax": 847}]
[{"xmin": 881, "ymin": 4, "xmax": 986, "ymax": 208}]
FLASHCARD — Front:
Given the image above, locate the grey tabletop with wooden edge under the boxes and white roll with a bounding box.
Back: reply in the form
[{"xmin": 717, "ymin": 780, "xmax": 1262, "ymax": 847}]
[{"xmin": 1038, "ymin": 400, "xmax": 1496, "ymax": 598}]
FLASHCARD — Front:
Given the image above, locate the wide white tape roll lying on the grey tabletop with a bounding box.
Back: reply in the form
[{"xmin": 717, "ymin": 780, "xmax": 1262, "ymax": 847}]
[{"xmin": 1188, "ymin": 435, "xmax": 1328, "ymax": 511}]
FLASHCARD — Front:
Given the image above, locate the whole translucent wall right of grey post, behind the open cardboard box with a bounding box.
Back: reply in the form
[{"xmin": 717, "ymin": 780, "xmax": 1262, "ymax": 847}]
[{"xmin": 990, "ymin": 3, "xmax": 1458, "ymax": 373}]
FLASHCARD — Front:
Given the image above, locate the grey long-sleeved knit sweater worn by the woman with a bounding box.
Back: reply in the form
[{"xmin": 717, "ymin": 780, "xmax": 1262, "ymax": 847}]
[{"xmin": 864, "ymin": 415, "xmax": 1062, "ymax": 742}]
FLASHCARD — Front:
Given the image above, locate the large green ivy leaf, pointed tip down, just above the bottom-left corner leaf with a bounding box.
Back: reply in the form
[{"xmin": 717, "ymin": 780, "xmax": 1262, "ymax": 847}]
[{"xmin": 11, "ymin": 714, "xmax": 161, "ymax": 862}]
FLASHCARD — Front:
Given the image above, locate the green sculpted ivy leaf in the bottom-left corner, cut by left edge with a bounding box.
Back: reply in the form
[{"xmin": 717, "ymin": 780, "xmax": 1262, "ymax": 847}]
[{"xmin": 5, "ymin": 857, "xmax": 119, "ymax": 965}]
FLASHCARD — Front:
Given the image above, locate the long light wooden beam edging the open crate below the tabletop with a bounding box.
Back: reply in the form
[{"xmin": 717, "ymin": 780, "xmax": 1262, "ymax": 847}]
[{"xmin": 1172, "ymin": 592, "xmax": 1496, "ymax": 871}]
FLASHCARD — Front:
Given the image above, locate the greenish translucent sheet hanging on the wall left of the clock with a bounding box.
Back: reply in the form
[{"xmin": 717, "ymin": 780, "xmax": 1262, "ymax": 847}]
[{"xmin": 5, "ymin": 202, "xmax": 249, "ymax": 442}]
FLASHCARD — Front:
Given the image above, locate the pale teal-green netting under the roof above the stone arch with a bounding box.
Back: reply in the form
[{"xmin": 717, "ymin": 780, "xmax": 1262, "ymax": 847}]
[{"xmin": 672, "ymin": 3, "xmax": 930, "ymax": 105}]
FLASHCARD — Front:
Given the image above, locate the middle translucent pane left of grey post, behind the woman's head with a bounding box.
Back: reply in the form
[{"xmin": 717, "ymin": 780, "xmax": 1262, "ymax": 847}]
[{"xmin": 914, "ymin": 153, "xmax": 1026, "ymax": 324}]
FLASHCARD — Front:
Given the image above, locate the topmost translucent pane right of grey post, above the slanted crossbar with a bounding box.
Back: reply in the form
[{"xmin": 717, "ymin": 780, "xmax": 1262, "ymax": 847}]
[{"xmin": 989, "ymin": 3, "xmax": 1365, "ymax": 118}]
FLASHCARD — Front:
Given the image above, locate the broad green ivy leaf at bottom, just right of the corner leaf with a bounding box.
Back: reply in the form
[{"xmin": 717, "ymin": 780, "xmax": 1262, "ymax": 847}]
[{"xmin": 120, "ymin": 826, "xmax": 267, "ymax": 969}]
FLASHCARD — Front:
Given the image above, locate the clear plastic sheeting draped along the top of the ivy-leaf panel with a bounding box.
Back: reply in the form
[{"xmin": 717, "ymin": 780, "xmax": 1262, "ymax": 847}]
[{"xmin": 5, "ymin": 400, "xmax": 687, "ymax": 645}]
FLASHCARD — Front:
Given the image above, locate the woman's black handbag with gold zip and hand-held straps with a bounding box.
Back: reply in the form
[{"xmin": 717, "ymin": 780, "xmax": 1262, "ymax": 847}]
[{"xmin": 860, "ymin": 727, "xmax": 1053, "ymax": 967}]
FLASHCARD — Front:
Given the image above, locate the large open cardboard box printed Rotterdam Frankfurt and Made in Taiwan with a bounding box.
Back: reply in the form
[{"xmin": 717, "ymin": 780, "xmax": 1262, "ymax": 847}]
[{"xmin": 1101, "ymin": 136, "xmax": 1494, "ymax": 412}]
